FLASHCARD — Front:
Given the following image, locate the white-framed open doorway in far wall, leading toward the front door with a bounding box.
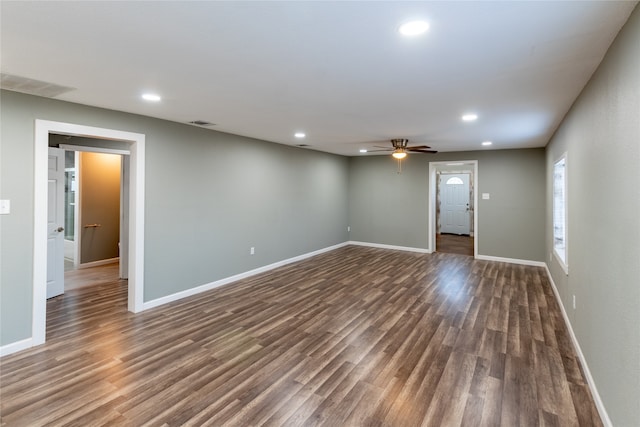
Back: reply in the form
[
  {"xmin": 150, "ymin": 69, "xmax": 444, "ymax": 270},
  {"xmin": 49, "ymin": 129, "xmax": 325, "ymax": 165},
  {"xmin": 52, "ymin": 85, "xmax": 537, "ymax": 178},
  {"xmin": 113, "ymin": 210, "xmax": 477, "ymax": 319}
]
[{"xmin": 429, "ymin": 160, "xmax": 477, "ymax": 256}]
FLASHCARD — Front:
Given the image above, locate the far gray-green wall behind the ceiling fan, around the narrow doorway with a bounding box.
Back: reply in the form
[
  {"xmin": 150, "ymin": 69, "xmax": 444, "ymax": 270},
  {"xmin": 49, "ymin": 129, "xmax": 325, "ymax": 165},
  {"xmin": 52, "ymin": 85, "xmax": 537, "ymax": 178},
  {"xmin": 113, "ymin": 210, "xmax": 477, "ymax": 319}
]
[{"xmin": 349, "ymin": 148, "xmax": 545, "ymax": 261}]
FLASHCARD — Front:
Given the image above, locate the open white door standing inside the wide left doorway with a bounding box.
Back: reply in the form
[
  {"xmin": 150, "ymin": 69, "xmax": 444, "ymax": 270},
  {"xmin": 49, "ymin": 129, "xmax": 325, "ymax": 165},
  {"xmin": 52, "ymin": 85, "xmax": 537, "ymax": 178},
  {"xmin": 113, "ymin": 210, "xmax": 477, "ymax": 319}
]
[{"xmin": 47, "ymin": 148, "xmax": 64, "ymax": 298}]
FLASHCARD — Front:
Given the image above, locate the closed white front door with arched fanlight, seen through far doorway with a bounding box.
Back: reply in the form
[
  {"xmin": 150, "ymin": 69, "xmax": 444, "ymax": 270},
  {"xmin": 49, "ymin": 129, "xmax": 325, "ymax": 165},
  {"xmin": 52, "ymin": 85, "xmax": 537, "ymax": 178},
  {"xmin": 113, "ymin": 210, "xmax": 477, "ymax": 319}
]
[{"xmin": 440, "ymin": 173, "xmax": 471, "ymax": 235}]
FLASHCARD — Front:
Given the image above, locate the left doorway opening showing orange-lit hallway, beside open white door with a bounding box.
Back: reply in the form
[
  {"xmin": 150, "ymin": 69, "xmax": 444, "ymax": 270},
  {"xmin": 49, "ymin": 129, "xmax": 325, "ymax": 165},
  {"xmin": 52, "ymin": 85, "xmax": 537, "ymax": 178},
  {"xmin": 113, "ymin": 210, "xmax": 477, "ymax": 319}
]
[{"xmin": 47, "ymin": 134, "xmax": 129, "ymax": 297}]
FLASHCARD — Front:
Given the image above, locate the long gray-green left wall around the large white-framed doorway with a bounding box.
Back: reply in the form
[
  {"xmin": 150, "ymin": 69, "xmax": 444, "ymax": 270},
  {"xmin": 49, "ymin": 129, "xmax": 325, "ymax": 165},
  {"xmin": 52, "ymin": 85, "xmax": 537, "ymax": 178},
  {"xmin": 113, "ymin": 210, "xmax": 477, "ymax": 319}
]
[{"xmin": 0, "ymin": 91, "xmax": 349, "ymax": 345}]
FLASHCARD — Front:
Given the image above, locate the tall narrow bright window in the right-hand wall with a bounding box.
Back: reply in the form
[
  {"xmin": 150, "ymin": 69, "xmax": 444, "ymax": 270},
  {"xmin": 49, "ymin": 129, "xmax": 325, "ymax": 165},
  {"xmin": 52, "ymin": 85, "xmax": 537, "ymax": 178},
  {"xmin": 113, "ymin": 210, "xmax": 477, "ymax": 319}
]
[{"xmin": 553, "ymin": 153, "xmax": 569, "ymax": 274}]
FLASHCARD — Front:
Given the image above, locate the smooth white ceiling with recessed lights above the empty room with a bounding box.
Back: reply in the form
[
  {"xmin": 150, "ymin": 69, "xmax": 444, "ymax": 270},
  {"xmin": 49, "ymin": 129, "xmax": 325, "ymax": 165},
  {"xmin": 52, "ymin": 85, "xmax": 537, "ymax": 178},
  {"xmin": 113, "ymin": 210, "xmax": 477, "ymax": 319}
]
[{"xmin": 0, "ymin": 0, "xmax": 637, "ymax": 155}]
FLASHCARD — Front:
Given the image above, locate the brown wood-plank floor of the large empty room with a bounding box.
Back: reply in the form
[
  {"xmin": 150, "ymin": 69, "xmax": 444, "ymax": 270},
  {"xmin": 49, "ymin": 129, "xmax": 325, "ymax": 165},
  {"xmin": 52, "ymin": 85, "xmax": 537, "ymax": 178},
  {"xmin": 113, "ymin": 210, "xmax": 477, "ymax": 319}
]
[{"xmin": 0, "ymin": 246, "xmax": 602, "ymax": 427}]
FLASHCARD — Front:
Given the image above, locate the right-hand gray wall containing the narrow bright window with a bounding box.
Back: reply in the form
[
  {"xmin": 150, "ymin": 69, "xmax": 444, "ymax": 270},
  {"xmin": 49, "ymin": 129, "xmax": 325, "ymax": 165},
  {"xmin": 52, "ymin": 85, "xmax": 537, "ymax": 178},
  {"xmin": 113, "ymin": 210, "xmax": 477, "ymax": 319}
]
[{"xmin": 546, "ymin": 7, "xmax": 640, "ymax": 426}]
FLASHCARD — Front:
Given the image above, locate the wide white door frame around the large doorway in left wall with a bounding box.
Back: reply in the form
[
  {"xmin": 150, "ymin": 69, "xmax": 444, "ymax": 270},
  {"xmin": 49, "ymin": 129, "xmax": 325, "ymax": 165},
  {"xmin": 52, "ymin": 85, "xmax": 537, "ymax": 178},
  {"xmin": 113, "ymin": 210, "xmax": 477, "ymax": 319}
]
[{"xmin": 31, "ymin": 119, "xmax": 145, "ymax": 345}]
